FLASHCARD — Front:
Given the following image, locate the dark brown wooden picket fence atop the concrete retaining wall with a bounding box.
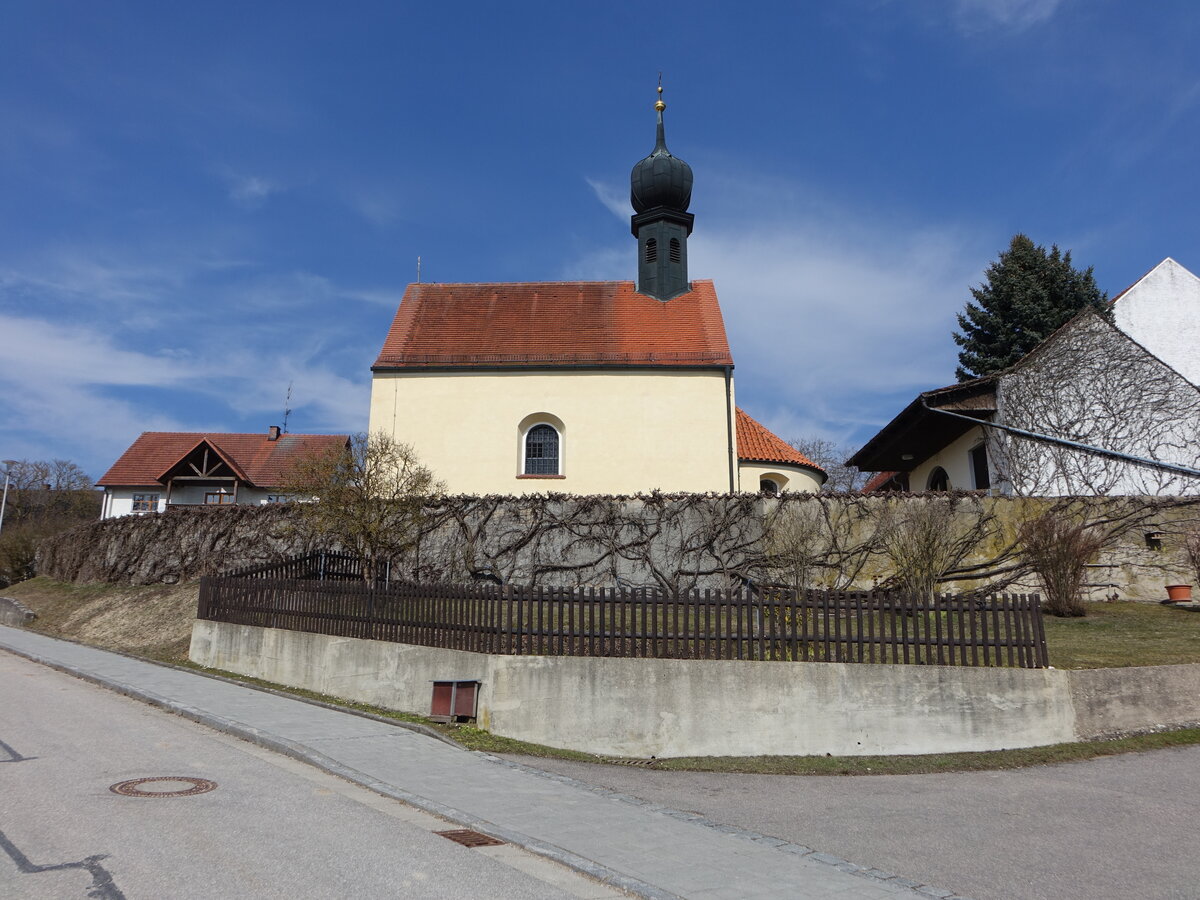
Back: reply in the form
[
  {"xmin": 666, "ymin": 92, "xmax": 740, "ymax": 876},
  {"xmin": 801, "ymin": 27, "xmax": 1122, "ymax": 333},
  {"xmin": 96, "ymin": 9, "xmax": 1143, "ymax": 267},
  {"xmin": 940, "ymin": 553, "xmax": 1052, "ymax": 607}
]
[{"xmin": 198, "ymin": 564, "xmax": 1046, "ymax": 668}]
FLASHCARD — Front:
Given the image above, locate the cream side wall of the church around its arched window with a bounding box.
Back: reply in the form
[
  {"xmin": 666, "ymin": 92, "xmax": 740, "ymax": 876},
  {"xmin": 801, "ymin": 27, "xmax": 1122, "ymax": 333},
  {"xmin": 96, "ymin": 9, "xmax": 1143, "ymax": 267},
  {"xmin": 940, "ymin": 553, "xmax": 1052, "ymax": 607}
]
[{"xmin": 368, "ymin": 368, "xmax": 733, "ymax": 493}]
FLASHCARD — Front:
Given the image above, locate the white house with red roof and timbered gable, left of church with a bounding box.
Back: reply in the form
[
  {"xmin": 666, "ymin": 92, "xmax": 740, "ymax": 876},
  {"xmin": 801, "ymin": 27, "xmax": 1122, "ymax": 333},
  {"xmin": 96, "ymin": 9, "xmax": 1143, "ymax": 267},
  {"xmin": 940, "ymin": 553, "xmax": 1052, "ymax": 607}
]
[{"xmin": 96, "ymin": 426, "xmax": 349, "ymax": 518}]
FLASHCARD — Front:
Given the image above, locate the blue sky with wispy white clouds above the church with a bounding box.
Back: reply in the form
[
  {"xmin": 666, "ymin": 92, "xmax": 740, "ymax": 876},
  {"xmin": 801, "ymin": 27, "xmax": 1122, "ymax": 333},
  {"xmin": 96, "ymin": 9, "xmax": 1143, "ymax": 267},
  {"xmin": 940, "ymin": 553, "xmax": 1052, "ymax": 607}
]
[{"xmin": 0, "ymin": 0, "xmax": 1200, "ymax": 476}]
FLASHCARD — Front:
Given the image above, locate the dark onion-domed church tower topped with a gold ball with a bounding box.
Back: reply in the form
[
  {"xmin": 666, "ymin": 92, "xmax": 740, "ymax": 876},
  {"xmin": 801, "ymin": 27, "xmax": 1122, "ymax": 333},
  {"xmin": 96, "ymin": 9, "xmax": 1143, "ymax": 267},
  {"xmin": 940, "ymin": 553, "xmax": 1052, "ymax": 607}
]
[{"xmin": 629, "ymin": 84, "xmax": 695, "ymax": 301}]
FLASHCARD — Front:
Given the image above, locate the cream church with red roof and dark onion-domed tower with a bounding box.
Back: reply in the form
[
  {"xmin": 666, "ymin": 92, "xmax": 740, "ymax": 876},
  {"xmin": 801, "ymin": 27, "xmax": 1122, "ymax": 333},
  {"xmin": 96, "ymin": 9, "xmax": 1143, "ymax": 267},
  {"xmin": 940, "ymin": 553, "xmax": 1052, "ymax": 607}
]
[{"xmin": 370, "ymin": 88, "xmax": 826, "ymax": 494}]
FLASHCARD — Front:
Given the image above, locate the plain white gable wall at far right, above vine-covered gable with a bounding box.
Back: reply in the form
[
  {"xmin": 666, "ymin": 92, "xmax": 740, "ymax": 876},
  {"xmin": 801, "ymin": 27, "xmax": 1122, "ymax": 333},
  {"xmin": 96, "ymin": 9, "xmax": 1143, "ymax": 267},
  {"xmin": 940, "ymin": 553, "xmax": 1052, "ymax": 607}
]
[{"xmin": 1112, "ymin": 258, "xmax": 1200, "ymax": 384}]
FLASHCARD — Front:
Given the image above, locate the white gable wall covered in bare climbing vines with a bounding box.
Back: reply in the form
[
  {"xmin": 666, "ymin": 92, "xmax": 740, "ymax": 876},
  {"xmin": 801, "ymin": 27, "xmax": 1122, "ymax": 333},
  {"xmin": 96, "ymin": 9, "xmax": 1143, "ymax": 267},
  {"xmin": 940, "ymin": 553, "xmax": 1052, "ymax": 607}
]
[{"xmin": 988, "ymin": 313, "xmax": 1200, "ymax": 497}]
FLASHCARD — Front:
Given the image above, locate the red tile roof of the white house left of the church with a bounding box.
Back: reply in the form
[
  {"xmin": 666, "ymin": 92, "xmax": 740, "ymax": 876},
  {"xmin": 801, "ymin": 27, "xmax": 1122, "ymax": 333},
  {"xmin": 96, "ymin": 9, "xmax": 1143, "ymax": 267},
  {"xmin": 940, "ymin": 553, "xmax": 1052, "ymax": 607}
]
[{"xmin": 96, "ymin": 431, "xmax": 349, "ymax": 487}]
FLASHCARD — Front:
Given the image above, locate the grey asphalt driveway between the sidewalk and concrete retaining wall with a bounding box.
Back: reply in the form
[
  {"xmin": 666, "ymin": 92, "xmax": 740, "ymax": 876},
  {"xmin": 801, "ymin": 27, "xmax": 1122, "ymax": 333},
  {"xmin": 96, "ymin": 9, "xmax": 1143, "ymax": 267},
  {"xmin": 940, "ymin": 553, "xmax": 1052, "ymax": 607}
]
[{"xmin": 511, "ymin": 746, "xmax": 1200, "ymax": 900}]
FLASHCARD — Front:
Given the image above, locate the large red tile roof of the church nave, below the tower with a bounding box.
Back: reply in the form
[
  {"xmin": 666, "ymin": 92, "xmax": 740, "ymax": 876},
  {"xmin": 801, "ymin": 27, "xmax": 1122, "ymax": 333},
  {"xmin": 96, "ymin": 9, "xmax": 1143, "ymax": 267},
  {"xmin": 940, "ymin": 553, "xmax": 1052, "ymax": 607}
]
[{"xmin": 374, "ymin": 281, "xmax": 733, "ymax": 370}]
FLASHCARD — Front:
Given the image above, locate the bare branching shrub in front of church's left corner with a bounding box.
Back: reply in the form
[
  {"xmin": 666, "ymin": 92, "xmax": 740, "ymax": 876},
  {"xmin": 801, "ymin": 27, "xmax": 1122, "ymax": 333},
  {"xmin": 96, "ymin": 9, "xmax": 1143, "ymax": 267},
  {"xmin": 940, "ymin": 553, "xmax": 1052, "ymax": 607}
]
[{"xmin": 283, "ymin": 432, "xmax": 444, "ymax": 583}]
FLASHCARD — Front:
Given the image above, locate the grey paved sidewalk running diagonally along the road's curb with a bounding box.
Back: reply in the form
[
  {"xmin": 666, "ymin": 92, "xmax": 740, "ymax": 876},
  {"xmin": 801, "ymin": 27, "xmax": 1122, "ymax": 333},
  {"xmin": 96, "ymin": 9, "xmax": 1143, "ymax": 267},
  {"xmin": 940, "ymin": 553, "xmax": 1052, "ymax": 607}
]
[{"xmin": 0, "ymin": 626, "xmax": 955, "ymax": 900}]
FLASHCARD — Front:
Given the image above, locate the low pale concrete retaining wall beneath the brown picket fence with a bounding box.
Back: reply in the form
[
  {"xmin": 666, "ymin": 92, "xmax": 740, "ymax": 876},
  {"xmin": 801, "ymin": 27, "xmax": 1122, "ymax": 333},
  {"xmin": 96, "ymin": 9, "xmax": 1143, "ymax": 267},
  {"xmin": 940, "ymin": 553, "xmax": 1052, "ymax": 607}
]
[{"xmin": 182, "ymin": 620, "xmax": 1200, "ymax": 757}]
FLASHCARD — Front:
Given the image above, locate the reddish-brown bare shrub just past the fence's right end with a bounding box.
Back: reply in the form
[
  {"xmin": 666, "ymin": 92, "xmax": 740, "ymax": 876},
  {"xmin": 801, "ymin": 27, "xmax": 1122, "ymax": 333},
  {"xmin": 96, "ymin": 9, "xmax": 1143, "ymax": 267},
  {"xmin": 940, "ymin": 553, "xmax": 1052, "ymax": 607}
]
[{"xmin": 1021, "ymin": 510, "xmax": 1105, "ymax": 616}]
